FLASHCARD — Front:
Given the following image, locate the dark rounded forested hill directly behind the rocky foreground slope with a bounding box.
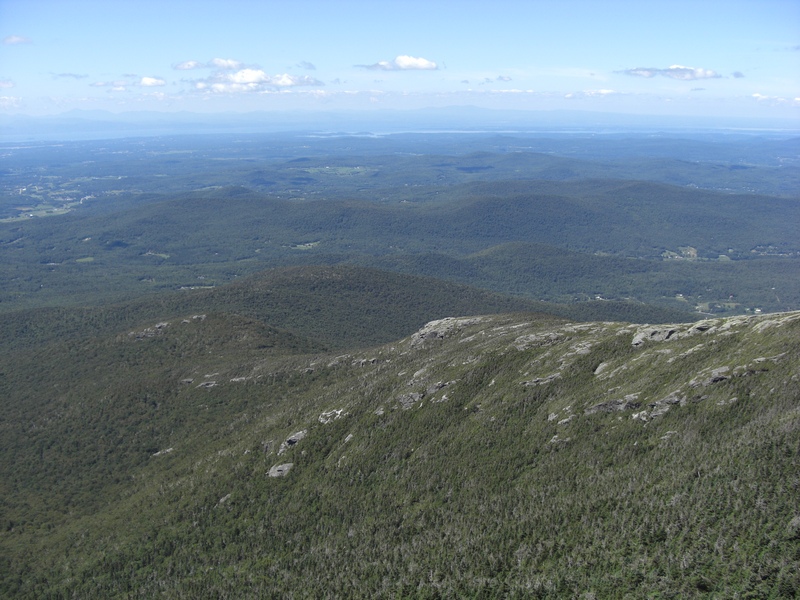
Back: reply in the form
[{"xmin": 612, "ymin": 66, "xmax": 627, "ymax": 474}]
[{"xmin": 0, "ymin": 265, "xmax": 693, "ymax": 352}]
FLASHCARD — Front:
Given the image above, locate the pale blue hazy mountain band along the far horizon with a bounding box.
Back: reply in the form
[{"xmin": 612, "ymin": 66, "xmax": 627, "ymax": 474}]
[{"xmin": 0, "ymin": 106, "xmax": 800, "ymax": 141}]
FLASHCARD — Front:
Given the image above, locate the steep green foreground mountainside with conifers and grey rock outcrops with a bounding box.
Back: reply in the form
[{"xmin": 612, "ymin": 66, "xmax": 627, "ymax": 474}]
[{"xmin": 0, "ymin": 313, "xmax": 800, "ymax": 598}]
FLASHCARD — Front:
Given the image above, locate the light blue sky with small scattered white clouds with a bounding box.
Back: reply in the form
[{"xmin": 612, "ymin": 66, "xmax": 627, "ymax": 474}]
[{"xmin": 0, "ymin": 0, "xmax": 800, "ymax": 120}]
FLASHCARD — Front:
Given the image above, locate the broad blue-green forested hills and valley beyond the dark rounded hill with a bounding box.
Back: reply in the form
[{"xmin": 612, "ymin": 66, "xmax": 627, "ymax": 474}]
[{"xmin": 0, "ymin": 181, "xmax": 800, "ymax": 313}]
